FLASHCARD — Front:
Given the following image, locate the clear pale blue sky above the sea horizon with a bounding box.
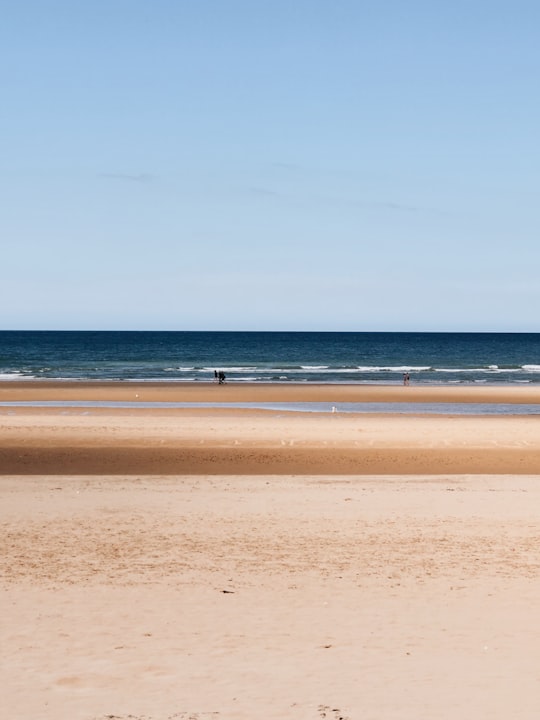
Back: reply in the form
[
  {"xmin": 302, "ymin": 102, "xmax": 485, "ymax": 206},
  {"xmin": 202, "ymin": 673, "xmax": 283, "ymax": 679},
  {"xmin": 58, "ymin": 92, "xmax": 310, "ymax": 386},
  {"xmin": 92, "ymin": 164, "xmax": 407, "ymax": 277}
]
[{"xmin": 0, "ymin": 0, "xmax": 540, "ymax": 332}]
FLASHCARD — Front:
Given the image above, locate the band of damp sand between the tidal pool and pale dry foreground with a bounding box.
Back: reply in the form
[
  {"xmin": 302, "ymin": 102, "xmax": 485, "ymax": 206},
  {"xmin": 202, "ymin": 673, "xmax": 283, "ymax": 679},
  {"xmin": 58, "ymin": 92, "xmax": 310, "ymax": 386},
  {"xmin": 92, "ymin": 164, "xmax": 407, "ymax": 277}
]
[{"xmin": 0, "ymin": 408, "xmax": 540, "ymax": 476}]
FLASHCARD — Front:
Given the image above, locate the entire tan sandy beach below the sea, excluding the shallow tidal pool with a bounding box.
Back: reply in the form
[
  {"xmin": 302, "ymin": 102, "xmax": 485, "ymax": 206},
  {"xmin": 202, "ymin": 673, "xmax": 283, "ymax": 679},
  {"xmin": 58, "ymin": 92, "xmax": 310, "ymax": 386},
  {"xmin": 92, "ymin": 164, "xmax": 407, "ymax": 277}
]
[{"xmin": 0, "ymin": 383, "xmax": 540, "ymax": 720}]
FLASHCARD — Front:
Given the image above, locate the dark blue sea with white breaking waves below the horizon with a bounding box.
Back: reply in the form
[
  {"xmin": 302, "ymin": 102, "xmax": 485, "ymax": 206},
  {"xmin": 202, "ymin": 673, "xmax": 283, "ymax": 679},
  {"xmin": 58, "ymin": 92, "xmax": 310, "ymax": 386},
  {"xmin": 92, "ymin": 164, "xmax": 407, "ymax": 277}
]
[{"xmin": 0, "ymin": 331, "xmax": 540, "ymax": 385}]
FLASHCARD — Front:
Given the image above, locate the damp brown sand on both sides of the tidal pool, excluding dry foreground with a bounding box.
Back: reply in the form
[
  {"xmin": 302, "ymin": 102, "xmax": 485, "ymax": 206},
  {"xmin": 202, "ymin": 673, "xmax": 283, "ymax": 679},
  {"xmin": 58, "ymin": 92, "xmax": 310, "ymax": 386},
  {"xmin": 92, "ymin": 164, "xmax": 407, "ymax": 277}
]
[{"xmin": 0, "ymin": 382, "xmax": 540, "ymax": 475}]
